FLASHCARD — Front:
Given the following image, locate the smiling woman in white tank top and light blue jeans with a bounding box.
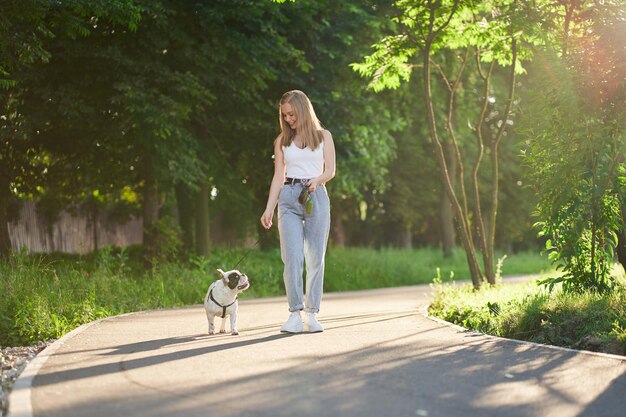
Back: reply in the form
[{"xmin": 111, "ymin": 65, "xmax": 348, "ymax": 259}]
[{"xmin": 261, "ymin": 90, "xmax": 335, "ymax": 333}]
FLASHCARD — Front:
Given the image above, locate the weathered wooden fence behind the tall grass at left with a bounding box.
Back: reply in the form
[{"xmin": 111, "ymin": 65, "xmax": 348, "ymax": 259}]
[{"xmin": 9, "ymin": 201, "xmax": 143, "ymax": 254}]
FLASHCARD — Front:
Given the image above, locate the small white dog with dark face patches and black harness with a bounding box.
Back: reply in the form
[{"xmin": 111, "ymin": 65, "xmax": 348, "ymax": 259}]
[{"xmin": 204, "ymin": 269, "xmax": 250, "ymax": 336}]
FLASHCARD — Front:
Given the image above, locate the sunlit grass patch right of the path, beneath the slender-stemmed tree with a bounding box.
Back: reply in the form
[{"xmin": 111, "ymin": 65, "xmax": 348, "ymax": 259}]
[{"xmin": 429, "ymin": 264, "xmax": 626, "ymax": 355}]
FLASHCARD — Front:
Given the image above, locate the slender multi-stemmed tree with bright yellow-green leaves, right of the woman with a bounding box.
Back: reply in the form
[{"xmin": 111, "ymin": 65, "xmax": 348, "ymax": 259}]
[{"xmin": 354, "ymin": 0, "xmax": 536, "ymax": 288}]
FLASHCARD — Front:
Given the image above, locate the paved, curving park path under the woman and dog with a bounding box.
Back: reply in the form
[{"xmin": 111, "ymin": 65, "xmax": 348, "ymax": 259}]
[{"xmin": 10, "ymin": 286, "xmax": 626, "ymax": 417}]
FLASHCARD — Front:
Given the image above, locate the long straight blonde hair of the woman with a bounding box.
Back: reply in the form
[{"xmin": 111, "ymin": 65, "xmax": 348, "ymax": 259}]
[{"xmin": 276, "ymin": 90, "xmax": 324, "ymax": 149}]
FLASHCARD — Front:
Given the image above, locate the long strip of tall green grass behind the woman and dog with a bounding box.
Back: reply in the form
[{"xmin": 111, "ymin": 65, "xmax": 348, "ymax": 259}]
[{"xmin": 0, "ymin": 247, "xmax": 548, "ymax": 346}]
